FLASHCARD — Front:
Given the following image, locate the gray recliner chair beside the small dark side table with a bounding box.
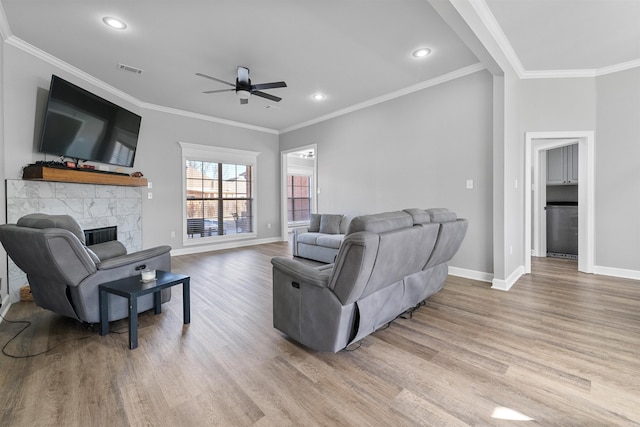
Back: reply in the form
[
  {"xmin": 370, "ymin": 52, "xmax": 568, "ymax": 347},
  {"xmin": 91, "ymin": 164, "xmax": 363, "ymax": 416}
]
[{"xmin": 0, "ymin": 214, "xmax": 171, "ymax": 323}]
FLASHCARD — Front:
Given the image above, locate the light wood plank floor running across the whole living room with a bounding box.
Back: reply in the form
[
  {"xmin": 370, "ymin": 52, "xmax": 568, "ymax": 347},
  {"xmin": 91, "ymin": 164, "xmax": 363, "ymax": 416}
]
[{"xmin": 0, "ymin": 243, "xmax": 640, "ymax": 426}]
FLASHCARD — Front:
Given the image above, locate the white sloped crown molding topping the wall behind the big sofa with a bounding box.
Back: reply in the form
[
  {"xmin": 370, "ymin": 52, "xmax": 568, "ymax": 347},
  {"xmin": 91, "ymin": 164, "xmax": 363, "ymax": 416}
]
[{"xmin": 280, "ymin": 62, "xmax": 485, "ymax": 134}]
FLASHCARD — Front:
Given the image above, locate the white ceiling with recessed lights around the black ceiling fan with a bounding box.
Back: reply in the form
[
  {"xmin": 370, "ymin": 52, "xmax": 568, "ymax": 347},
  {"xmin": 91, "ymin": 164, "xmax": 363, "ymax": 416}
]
[{"xmin": 0, "ymin": 0, "xmax": 640, "ymax": 131}]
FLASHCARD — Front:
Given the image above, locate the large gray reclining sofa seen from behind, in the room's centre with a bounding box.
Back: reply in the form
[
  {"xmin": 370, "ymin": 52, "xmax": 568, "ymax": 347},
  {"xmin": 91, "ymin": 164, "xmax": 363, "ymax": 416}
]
[{"xmin": 271, "ymin": 209, "xmax": 468, "ymax": 352}]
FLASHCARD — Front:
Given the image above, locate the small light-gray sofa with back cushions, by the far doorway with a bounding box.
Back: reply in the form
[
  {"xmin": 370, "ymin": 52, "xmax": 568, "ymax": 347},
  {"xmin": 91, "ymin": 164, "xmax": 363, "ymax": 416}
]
[{"xmin": 293, "ymin": 214, "xmax": 349, "ymax": 263}]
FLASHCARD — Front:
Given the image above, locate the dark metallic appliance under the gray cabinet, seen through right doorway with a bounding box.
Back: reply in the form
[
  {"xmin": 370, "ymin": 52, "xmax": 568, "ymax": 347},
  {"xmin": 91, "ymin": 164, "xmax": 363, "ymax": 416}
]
[{"xmin": 547, "ymin": 202, "xmax": 578, "ymax": 259}]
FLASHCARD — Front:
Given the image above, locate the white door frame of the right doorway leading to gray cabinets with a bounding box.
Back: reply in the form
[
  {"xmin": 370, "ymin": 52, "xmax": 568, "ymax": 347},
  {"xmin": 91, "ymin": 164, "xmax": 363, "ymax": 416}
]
[{"xmin": 524, "ymin": 131, "xmax": 595, "ymax": 273}]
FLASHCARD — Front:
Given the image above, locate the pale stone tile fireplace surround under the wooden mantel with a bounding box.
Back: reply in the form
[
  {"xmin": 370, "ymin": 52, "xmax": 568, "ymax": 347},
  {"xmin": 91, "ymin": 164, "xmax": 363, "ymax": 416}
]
[{"xmin": 6, "ymin": 179, "xmax": 142, "ymax": 302}]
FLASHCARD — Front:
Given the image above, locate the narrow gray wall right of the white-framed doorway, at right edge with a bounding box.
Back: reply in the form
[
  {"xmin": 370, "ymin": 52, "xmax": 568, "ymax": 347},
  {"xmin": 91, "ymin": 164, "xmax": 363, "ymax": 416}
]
[{"xmin": 595, "ymin": 68, "xmax": 640, "ymax": 277}]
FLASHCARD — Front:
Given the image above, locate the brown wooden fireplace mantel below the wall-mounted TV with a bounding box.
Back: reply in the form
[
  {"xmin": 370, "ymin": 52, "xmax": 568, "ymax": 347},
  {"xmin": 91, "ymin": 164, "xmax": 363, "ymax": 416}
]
[{"xmin": 22, "ymin": 165, "xmax": 147, "ymax": 187}]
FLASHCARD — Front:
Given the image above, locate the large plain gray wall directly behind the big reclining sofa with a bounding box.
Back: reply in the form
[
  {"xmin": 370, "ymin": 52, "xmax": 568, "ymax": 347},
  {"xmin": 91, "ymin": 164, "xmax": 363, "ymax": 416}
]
[{"xmin": 280, "ymin": 71, "xmax": 493, "ymax": 273}]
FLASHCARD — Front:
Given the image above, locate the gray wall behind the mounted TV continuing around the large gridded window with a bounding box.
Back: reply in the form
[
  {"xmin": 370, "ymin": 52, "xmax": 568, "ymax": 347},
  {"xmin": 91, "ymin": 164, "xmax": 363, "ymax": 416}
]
[{"xmin": 2, "ymin": 45, "xmax": 280, "ymax": 258}]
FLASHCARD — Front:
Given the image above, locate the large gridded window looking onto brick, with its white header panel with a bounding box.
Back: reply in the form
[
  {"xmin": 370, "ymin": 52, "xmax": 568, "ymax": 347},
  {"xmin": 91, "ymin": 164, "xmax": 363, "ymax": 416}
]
[{"xmin": 180, "ymin": 143, "xmax": 256, "ymax": 242}]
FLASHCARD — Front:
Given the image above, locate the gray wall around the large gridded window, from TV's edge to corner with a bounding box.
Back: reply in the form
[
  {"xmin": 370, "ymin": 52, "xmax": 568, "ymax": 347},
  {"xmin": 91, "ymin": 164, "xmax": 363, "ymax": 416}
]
[{"xmin": 136, "ymin": 110, "xmax": 280, "ymax": 249}]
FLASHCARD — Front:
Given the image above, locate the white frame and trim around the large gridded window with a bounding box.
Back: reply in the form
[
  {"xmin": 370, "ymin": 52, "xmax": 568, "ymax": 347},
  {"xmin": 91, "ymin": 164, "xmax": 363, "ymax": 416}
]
[{"xmin": 178, "ymin": 141, "xmax": 260, "ymax": 246}]
